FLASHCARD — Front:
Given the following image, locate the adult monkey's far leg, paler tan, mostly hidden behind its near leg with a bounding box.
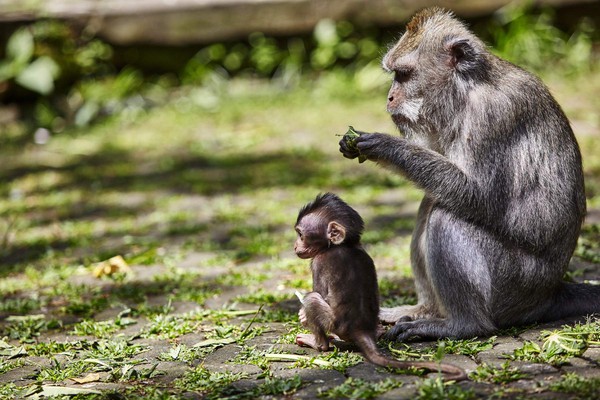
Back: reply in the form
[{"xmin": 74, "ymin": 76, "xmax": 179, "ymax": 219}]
[{"xmin": 379, "ymin": 196, "xmax": 441, "ymax": 324}]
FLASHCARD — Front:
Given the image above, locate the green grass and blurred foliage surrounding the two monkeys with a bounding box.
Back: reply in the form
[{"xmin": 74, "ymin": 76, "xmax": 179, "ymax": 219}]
[{"xmin": 0, "ymin": 3, "xmax": 600, "ymax": 398}]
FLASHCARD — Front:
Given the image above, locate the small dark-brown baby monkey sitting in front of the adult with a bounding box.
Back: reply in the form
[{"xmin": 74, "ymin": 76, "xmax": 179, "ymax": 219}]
[{"xmin": 294, "ymin": 193, "xmax": 467, "ymax": 380}]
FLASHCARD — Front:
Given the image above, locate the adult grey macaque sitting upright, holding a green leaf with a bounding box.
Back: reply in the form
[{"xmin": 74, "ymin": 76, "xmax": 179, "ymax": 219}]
[{"xmin": 340, "ymin": 8, "xmax": 600, "ymax": 341}]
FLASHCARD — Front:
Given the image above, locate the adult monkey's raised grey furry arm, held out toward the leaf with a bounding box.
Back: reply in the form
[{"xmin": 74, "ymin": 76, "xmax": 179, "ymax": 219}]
[{"xmin": 350, "ymin": 133, "xmax": 489, "ymax": 219}]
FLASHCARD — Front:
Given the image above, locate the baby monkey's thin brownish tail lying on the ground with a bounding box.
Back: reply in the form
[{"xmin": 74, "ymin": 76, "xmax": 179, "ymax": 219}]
[{"xmin": 355, "ymin": 334, "xmax": 467, "ymax": 381}]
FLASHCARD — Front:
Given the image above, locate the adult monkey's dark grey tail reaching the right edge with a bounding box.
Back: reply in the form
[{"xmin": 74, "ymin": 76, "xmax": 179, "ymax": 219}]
[{"xmin": 542, "ymin": 282, "xmax": 600, "ymax": 321}]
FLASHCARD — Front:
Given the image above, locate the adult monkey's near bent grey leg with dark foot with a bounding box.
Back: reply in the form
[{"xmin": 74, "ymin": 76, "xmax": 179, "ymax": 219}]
[{"xmin": 385, "ymin": 214, "xmax": 496, "ymax": 341}]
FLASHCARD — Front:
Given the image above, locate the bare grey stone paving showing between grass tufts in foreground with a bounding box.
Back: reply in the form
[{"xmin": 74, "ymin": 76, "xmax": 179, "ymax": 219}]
[{"xmin": 0, "ymin": 245, "xmax": 600, "ymax": 399}]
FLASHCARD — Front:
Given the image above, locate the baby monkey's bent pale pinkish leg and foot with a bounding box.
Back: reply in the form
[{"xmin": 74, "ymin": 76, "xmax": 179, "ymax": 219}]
[{"xmin": 296, "ymin": 292, "xmax": 334, "ymax": 351}]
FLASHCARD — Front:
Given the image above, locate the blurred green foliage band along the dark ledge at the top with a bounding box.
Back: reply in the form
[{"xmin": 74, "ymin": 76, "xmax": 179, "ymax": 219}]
[{"xmin": 0, "ymin": 6, "xmax": 594, "ymax": 132}]
